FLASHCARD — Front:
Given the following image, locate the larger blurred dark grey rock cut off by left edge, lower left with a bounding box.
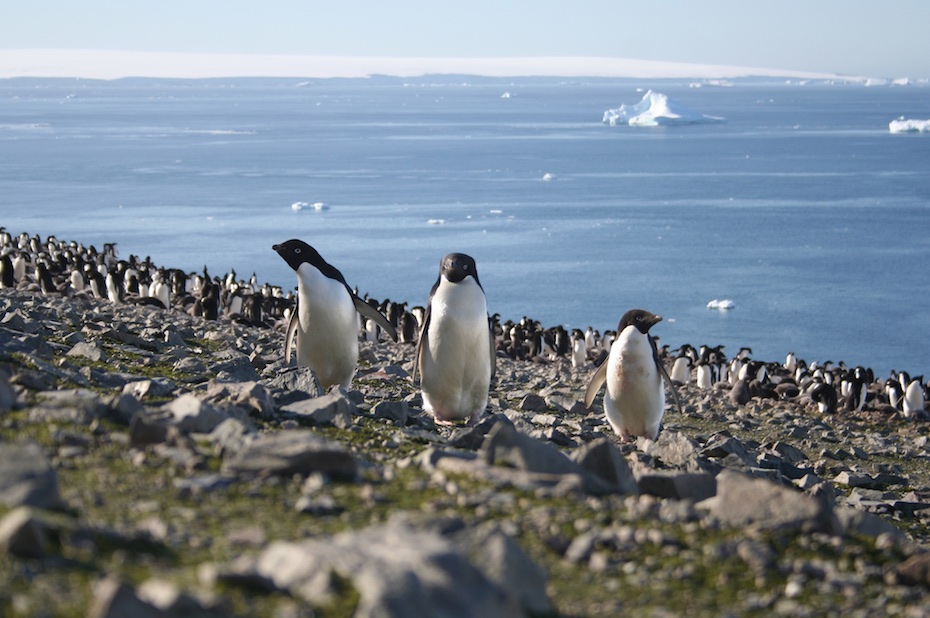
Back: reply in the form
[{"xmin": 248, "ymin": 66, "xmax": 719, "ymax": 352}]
[{"xmin": 0, "ymin": 442, "xmax": 65, "ymax": 509}]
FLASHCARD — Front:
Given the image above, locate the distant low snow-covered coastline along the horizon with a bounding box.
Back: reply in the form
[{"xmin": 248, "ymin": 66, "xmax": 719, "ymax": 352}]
[{"xmin": 0, "ymin": 49, "xmax": 865, "ymax": 82}]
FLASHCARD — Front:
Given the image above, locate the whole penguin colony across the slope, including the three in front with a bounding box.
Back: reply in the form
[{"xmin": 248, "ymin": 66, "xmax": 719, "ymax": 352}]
[{"xmin": 0, "ymin": 227, "xmax": 930, "ymax": 440}]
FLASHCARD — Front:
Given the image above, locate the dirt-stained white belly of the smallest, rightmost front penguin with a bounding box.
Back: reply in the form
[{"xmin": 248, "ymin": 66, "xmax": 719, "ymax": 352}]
[{"xmin": 604, "ymin": 328, "xmax": 665, "ymax": 440}]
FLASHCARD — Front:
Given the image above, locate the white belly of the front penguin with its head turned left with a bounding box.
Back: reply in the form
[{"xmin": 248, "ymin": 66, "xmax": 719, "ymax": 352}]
[{"xmin": 297, "ymin": 264, "xmax": 358, "ymax": 388}]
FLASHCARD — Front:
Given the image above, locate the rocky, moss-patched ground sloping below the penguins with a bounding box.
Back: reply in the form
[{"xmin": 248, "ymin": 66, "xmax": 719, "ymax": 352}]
[{"xmin": 0, "ymin": 290, "xmax": 930, "ymax": 617}]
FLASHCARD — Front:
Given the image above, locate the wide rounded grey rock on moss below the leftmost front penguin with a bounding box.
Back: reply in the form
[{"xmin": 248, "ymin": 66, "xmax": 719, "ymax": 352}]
[{"xmin": 222, "ymin": 429, "xmax": 358, "ymax": 480}]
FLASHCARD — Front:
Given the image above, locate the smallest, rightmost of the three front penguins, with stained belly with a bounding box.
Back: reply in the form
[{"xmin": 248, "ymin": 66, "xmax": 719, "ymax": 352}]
[{"xmin": 584, "ymin": 309, "xmax": 681, "ymax": 442}]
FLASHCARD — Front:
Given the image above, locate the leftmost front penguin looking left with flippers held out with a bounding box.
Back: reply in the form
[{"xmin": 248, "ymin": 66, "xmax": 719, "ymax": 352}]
[{"xmin": 272, "ymin": 239, "xmax": 397, "ymax": 388}]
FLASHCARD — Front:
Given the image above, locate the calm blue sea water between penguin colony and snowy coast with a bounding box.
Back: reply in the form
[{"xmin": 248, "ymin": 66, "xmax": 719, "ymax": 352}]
[{"xmin": 0, "ymin": 76, "xmax": 930, "ymax": 376}]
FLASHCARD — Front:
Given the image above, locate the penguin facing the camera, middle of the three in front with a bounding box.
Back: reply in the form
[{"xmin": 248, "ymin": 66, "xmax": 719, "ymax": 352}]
[{"xmin": 414, "ymin": 253, "xmax": 496, "ymax": 424}]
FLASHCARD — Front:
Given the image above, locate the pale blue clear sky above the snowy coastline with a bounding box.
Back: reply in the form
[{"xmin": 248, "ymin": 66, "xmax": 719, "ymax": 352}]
[{"xmin": 0, "ymin": 0, "xmax": 930, "ymax": 79}]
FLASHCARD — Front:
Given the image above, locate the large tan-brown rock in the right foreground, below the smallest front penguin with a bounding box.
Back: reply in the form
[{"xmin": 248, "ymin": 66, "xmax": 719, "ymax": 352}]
[{"xmin": 702, "ymin": 470, "xmax": 841, "ymax": 534}]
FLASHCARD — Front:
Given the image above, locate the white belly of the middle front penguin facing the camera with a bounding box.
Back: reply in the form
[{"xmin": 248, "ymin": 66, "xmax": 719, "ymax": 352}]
[{"xmin": 420, "ymin": 282, "xmax": 491, "ymax": 420}]
